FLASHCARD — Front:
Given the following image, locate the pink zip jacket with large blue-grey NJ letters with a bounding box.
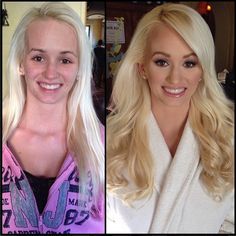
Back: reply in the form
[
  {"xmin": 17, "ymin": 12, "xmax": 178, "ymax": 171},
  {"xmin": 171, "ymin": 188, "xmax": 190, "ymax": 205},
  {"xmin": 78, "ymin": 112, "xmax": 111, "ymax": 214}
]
[{"xmin": 2, "ymin": 145, "xmax": 105, "ymax": 234}]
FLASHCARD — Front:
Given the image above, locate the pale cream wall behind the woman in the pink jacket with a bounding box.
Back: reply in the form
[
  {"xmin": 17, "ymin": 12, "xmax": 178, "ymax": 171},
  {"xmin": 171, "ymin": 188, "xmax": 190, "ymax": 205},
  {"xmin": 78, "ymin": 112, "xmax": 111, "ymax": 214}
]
[{"xmin": 2, "ymin": 2, "xmax": 87, "ymax": 95}]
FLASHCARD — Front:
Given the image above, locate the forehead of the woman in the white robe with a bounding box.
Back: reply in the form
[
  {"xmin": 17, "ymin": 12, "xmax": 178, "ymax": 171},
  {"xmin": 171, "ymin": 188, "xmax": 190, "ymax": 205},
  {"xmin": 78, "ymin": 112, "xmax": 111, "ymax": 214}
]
[{"xmin": 147, "ymin": 24, "xmax": 193, "ymax": 54}]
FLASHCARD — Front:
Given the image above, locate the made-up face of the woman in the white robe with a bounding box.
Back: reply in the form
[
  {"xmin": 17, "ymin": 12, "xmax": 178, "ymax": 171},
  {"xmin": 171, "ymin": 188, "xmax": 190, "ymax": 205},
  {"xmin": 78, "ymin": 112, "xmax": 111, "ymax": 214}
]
[{"xmin": 139, "ymin": 25, "xmax": 202, "ymax": 109}]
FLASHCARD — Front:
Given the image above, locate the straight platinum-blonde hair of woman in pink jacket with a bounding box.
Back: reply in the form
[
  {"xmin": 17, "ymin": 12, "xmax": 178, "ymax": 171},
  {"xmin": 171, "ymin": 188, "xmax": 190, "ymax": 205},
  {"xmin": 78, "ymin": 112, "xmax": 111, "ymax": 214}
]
[{"xmin": 3, "ymin": 3, "xmax": 104, "ymax": 208}]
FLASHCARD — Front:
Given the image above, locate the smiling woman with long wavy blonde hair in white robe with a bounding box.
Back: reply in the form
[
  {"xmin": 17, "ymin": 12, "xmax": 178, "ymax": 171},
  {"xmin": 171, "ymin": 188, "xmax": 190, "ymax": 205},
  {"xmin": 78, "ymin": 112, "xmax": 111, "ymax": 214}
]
[{"xmin": 106, "ymin": 3, "xmax": 234, "ymax": 233}]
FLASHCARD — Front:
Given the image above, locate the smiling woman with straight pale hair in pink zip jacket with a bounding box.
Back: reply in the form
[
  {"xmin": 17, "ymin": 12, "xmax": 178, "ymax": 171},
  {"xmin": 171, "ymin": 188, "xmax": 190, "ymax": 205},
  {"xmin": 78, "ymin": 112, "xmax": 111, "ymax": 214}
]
[{"xmin": 2, "ymin": 3, "xmax": 104, "ymax": 234}]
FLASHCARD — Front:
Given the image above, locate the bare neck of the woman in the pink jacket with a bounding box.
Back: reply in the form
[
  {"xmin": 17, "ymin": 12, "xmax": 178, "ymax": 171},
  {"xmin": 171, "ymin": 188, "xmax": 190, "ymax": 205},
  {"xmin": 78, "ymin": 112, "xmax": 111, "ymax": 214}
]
[{"xmin": 19, "ymin": 100, "xmax": 67, "ymax": 134}]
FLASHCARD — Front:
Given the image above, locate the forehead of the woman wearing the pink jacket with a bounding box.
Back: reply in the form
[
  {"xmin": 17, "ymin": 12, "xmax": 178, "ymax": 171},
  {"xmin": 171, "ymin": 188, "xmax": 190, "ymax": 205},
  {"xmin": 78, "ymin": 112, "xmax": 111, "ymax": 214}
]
[{"xmin": 26, "ymin": 18, "xmax": 77, "ymax": 50}]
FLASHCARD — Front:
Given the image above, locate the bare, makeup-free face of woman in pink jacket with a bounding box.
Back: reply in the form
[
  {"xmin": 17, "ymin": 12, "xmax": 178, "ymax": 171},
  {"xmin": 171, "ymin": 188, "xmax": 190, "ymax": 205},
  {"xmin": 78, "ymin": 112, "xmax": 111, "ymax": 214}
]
[{"xmin": 20, "ymin": 19, "xmax": 79, "ymax": 104}]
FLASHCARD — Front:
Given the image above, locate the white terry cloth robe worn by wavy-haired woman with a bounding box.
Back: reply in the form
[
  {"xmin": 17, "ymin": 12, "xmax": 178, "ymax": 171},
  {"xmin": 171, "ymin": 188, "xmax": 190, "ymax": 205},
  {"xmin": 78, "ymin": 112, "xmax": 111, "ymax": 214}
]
[{"xmin": 107, "ymin": 113, "xmax": 234, "ymax": 233}]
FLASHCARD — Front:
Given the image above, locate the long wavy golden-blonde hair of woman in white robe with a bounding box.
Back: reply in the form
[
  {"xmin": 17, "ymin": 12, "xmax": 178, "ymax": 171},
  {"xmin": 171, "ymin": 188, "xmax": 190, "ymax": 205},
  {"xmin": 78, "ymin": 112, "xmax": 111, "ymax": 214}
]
[{"xmin": 107, "ymin": 3, "xmax": 234, "ymax": 203}]
